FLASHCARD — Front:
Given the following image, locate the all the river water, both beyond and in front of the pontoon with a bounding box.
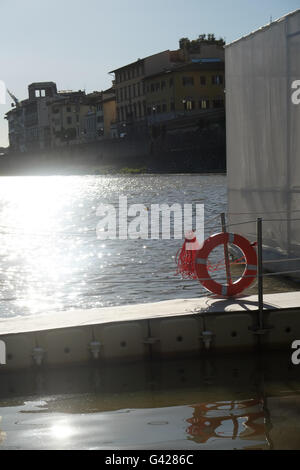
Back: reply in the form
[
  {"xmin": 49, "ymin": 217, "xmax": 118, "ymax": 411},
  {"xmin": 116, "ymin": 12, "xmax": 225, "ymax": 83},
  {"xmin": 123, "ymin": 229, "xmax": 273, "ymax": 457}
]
[{"xmin": 0, "ymin": 175, "xmax": 300, "ymax": 450}]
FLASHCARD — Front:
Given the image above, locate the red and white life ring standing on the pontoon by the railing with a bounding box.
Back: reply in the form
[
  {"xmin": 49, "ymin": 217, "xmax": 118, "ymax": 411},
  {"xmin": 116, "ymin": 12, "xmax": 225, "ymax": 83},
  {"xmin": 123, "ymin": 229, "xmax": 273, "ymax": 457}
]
[{"xmin": 195, "ymin": 233, "xmax": 257, "ymax": 297}]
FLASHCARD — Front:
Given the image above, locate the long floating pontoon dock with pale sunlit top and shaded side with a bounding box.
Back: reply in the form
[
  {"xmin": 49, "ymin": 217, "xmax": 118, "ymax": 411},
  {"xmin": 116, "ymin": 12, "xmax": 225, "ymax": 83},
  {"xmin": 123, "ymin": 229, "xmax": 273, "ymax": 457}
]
[{"xmin": 0, "ymin": 292, "xmax": 300, "ymax": 373}]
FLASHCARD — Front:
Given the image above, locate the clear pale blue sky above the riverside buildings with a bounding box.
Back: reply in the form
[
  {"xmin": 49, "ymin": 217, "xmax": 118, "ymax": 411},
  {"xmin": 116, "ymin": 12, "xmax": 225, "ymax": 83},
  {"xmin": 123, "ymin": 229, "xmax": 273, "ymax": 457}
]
[{"xmin": 0, "ymin": 0, "xmax": 300, "ymax": 146}]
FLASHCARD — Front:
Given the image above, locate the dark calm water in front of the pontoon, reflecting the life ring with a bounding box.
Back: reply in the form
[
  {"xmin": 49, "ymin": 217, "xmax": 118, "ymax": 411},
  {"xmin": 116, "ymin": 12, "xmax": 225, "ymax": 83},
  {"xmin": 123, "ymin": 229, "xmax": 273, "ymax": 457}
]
[{"xmin": 0, "ymin": 354, "xmax": 300, "ymax": 450}]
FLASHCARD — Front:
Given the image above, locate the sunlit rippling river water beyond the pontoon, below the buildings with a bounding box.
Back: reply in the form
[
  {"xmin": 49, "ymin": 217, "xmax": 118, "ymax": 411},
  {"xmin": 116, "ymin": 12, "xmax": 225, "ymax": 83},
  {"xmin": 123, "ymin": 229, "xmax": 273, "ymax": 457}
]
[{"xmin": 0, "ymin": 174, "xmax": 294, "ymax": 318}]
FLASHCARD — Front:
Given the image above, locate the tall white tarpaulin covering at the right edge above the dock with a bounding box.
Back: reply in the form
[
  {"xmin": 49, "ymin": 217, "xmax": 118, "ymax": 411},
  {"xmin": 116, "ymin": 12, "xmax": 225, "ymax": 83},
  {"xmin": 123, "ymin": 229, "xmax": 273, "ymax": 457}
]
[{"xmin": 226, "ymin": 10, "xmax": 300, "ymax": 274}]
